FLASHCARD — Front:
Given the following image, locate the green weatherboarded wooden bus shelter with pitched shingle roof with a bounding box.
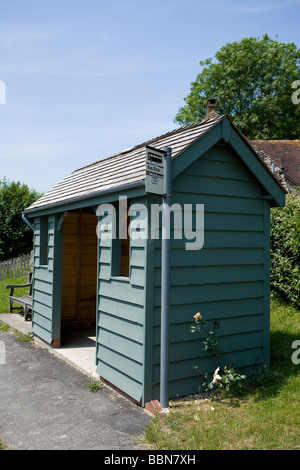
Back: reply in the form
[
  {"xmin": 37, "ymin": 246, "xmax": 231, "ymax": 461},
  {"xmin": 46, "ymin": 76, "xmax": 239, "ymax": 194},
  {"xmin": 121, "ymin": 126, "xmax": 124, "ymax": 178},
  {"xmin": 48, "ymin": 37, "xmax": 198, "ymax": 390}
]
[{"xmin": 24, "ymin": 111, "xmax": 286, "ymax": 406}]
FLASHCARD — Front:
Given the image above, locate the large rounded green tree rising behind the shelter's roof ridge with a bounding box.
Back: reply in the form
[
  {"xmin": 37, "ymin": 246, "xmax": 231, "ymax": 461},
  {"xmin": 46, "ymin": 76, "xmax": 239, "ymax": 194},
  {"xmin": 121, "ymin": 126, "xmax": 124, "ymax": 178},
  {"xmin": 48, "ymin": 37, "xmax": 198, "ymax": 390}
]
[{"xmin": 175, "ymin": 34, "xmax": 300, "ymax": 139}]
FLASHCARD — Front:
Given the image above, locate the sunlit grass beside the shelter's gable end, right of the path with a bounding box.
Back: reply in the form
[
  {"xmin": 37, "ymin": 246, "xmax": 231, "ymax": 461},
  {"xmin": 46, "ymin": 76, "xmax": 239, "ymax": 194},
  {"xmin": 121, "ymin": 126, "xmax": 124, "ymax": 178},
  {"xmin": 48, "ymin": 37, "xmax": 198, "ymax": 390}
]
[{"xmin": 145, "ymin": 298, "xmax": 300, "ymax": 450}]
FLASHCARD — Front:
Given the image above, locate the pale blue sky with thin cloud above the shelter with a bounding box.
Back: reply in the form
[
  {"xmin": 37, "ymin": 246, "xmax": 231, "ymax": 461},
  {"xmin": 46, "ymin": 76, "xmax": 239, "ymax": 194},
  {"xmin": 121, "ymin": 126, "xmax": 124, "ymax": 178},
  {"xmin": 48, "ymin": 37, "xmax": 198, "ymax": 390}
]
[{"xmin": 0, "ymin": 0, "xmax": 300, "ymax": 192}]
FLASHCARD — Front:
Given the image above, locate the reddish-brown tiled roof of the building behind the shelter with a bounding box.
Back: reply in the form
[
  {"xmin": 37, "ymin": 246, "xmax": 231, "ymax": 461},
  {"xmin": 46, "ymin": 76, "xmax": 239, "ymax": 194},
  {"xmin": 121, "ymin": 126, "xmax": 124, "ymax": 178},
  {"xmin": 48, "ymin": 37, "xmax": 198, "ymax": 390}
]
[{"xmin": 253, "ymin": 140, "xmax": 300, "ymax": 186}]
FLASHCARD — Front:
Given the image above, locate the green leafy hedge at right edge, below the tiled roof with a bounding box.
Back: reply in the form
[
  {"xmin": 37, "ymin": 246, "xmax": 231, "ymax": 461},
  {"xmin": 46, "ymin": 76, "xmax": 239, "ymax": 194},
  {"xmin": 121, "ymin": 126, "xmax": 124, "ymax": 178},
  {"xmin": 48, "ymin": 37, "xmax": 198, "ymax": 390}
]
[{"xmin": 271, "ymin": 194, "xmax": 300, "ymax": 308}]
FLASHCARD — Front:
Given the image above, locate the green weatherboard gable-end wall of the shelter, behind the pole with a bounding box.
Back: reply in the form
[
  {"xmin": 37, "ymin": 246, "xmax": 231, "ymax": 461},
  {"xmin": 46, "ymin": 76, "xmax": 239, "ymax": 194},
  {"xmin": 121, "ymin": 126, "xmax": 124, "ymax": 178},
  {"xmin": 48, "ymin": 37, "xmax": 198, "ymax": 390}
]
[{"xmin": 152, "ymin": 144, "xmax": 269, "ymax": 398}]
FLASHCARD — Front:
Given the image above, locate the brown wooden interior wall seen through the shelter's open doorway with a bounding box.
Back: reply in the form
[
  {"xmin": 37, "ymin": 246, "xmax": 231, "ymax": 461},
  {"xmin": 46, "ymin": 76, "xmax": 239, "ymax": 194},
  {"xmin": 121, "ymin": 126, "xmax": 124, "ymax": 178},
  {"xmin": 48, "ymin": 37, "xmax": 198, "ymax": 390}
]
[{"xmin": 61, "ymin": 209, "xmax": 97, "ymax": 323}]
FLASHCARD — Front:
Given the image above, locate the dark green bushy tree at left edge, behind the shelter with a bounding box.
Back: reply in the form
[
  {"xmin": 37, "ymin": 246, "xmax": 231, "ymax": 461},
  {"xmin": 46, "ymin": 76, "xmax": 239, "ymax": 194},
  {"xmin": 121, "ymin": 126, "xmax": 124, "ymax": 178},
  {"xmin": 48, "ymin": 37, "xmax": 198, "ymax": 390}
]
[{"xmin": 0, "ymin": 178, "xmax": 40, "ymax": 261}]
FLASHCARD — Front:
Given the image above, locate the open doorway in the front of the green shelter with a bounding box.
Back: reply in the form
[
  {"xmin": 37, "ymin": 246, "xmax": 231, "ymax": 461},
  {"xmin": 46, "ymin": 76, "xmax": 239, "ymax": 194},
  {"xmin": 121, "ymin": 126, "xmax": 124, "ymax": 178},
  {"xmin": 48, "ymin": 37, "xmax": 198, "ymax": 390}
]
[{"xmin": 61, "ymin": 207, "xmax": 98, "ymax": 363}]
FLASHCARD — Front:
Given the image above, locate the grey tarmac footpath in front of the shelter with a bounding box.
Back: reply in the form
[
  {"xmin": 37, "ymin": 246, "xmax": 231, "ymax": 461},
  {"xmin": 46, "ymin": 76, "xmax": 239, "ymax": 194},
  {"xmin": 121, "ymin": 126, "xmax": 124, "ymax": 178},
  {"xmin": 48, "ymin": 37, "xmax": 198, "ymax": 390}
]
[{"xmin": 0, "ymin": 331, "xmax": 151, "ymax": 450}]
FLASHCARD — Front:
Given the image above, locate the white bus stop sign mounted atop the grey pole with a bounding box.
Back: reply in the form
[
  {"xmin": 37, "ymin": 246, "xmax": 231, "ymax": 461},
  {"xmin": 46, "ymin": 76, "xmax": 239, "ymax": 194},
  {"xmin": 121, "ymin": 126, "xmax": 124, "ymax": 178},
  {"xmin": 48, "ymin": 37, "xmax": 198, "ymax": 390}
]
[{"xmin": 146, "ymin": 147, "xmax": 165, "ymax": 196}]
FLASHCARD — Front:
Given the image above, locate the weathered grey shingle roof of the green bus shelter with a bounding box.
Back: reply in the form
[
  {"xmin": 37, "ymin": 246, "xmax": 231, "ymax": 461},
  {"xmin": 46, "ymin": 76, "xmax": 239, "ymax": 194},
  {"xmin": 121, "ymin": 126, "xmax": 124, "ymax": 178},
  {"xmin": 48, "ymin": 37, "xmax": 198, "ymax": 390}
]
[{"xmin": 26, "ymin": 115, "xmax": 286, "ymax": 212}]
